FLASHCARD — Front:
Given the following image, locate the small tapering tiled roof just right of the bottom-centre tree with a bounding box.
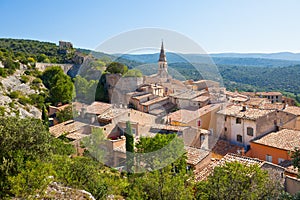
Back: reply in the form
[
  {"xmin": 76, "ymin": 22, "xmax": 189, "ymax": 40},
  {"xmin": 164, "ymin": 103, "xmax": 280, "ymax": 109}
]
[{"xmin": 184, "ymin": 146, "xmax": 210, "ymax": 165}]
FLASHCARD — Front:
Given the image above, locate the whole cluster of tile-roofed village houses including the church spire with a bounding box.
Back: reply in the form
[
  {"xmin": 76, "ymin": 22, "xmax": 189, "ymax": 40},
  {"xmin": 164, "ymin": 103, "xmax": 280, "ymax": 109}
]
[{"xmin": 48, "ymin": 43, "xmax": 300, "ymax": 194}]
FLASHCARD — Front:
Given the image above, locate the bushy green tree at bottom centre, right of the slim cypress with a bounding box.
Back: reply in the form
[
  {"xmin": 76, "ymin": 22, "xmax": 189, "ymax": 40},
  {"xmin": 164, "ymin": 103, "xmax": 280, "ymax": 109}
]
[{"xmin": 124, "ymin": 134, "xmax": 193, "ymax": 200}]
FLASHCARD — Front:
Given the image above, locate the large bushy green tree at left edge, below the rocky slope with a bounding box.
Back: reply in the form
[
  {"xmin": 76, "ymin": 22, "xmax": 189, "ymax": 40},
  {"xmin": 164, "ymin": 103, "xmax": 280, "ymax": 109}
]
[{"xmin": 0, "ymin": 117, "xmax": 51, "ymax": 198}]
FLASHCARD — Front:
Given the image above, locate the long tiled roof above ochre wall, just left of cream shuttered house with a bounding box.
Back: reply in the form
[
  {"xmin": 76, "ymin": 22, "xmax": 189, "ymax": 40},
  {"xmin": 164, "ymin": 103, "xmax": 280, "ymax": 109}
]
[{"xmin": 168, "ymin": 104, "xmax": 220, "ymax": 123}]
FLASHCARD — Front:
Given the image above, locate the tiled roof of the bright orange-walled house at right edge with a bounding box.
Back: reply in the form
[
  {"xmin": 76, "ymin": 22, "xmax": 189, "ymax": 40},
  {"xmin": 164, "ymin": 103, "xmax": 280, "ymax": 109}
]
[{"xmin": 253, "ymin": 129, "xmax": 300, "ymax": 151}]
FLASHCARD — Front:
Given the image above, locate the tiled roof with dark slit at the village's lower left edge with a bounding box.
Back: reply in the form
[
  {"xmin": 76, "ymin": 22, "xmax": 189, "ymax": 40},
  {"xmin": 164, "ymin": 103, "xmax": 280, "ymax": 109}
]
[{"xmin": 49, "ymin": 120, "xmax": 87, "ymax": 137}]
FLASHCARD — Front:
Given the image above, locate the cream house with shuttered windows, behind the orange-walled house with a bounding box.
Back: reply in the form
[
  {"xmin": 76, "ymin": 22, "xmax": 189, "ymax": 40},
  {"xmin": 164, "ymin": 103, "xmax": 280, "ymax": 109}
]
[{"xmin": 216, "ymin": 105, "xmax": 295, "ymax": 149}]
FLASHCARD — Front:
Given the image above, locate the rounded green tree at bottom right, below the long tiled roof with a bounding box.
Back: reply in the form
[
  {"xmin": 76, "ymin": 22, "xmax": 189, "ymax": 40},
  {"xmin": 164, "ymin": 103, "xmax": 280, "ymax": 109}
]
[{"xmin": 196, "ymin": 162, "xmax": 281, "ymax": 200}]
